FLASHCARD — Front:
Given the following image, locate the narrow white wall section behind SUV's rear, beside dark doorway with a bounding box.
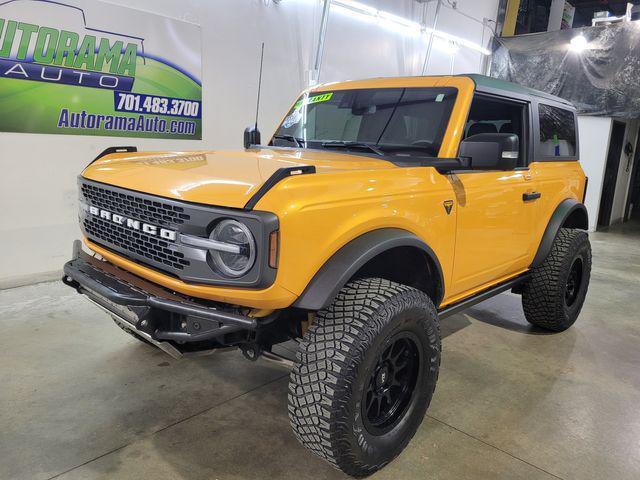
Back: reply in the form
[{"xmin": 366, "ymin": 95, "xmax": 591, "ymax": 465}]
[{"xmin": 578, "ymin": 116, "xmax": 613, "ymax": 231}]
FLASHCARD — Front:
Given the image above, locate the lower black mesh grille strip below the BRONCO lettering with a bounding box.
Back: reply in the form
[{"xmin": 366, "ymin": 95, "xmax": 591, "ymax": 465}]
[{"xmin": 83, "ymin": 217, "xmax": 191, "ymax": 270}]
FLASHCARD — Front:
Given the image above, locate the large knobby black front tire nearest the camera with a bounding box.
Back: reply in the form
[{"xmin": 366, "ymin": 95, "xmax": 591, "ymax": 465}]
[{"xmin": 288, "ymin": 278, "xmax": 440, "ymax": 477}]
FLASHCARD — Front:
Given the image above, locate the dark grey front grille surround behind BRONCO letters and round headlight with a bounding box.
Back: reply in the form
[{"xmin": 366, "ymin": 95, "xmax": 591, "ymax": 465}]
[{"xmin": 78, "ymin": 177, "xmax": 278, "ymax": 287}]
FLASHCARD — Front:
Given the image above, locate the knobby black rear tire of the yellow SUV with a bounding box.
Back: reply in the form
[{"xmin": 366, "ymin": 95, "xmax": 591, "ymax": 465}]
[{"xmin": 522, "ymin": 228, "xmax": 591, "ymax": 332}]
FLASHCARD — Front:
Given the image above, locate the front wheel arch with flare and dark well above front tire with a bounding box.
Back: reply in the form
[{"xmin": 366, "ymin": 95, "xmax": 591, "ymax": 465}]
[{"xmin": 293, "ymin": 228, "xmax": 444, "ymax": 310}]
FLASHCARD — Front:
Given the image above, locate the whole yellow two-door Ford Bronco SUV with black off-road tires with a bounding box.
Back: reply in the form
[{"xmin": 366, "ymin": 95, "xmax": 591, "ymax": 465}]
[{"xmin": 63, "ymin": 75, "xmax": 591, "ymax": 476}]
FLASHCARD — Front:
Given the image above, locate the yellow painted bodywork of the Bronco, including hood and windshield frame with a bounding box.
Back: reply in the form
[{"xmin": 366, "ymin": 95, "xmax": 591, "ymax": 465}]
[{"xmin": 83, "ymin": 73, "xmax": 585, "ymax": 310}]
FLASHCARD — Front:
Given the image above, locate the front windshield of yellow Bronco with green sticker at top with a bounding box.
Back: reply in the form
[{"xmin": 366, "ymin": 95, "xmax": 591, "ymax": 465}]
[{"xmin": 271, "ymin": 87, "xmax": 457, "ymax": 157}]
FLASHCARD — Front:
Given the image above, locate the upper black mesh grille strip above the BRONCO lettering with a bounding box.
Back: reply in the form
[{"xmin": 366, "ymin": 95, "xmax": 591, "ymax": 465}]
[{"xmin": 80, "ymin": 183, "xmax": 191, "ymax": 229}]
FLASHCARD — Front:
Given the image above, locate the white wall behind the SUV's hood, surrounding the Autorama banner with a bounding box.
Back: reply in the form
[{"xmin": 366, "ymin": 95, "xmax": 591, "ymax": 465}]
[{"xmin": 0, "ymin": 0, "xmax": 498, "ymax": 288}]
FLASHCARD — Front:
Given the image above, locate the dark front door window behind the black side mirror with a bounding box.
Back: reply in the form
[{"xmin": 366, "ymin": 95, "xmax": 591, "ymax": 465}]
[{"xmin": 464, "ymin": 95, "xmax": 528, "ymax": 167}]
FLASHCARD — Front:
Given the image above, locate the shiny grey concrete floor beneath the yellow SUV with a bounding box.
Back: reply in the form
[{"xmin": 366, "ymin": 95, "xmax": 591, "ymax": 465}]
[{"xmin": 0, "ymin": 224, "xmax": 640, "ymax": 480}]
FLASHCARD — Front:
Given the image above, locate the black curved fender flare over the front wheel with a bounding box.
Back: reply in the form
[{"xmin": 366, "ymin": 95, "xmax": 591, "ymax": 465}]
[{"xmin": 293, "ymin": 228, "xmax": 444, "ymax": 310}]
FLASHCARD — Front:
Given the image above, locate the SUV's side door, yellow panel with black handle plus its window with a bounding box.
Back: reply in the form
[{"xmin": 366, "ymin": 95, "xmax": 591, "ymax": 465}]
[{"xmin": 451, "ymin": 95, "xmax": 537, "ymax": 296}]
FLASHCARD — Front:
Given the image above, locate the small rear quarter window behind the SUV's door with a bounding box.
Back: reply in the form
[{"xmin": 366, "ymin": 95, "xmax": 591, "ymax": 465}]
[{"xmin": 538, "ymin": 103, "xmax": 576, "ymax": 157}]
